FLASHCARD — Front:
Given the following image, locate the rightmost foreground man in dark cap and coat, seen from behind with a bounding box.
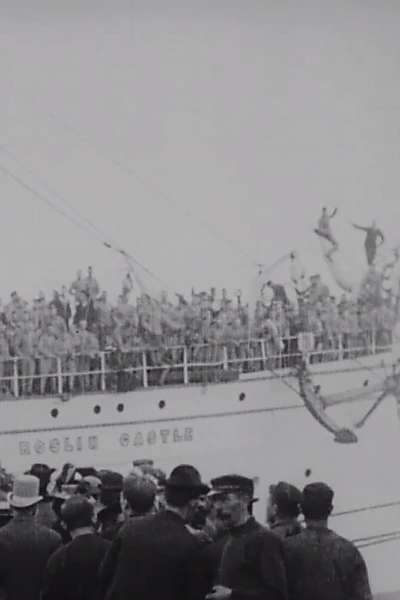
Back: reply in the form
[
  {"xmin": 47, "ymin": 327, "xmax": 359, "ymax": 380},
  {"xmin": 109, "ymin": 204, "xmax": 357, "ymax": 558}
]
[{"xmin": 283, "ymin": 482, "xmax": 372, "ymax": 600}]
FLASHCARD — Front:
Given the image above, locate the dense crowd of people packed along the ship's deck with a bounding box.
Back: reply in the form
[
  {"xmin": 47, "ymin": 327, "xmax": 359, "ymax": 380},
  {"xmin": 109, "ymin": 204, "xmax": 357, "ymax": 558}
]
[{"xmin": 0, "ymin": 267, "xmax": 395, "ymax": 395}]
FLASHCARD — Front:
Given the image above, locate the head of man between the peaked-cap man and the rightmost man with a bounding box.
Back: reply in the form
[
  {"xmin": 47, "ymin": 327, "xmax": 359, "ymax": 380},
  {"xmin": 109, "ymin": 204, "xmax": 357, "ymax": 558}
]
[{"xmin": 267, "ymin": 481, "xmax": 301, "ymax": 538}]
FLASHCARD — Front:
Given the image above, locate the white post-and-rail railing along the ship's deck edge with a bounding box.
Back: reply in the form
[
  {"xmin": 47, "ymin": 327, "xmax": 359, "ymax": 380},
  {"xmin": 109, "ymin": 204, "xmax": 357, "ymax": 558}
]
[{"xmin": 0, "ymin": 331, "xmax": 391, "ymax": 400}]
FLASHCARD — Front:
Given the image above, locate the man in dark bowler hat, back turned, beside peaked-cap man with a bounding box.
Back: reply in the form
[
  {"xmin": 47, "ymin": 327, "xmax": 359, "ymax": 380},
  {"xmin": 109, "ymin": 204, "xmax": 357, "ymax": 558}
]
[{"xmin": 100, "ymin": 465, "xmax": 209, "ymax": 600}]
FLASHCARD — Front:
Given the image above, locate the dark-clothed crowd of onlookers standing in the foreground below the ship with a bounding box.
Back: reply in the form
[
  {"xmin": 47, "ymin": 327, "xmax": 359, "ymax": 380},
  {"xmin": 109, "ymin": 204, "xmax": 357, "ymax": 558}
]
[{"xmin": 0, "ymin": 460, "xmax": 372, "ymax": 600}]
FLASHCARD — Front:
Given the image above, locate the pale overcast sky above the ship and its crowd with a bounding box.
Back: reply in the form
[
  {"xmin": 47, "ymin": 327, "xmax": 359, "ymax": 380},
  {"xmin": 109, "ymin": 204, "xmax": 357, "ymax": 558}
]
[{"xmin": 0, "ymin": 0, "xmax": 400, "ymax": 300}]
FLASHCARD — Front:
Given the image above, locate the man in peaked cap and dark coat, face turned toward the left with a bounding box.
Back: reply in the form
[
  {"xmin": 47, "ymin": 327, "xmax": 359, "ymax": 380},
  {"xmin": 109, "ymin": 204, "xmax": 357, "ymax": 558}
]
[{"xmin": 206, "ymin": 475, "xmax": 287, "ymax": 600}]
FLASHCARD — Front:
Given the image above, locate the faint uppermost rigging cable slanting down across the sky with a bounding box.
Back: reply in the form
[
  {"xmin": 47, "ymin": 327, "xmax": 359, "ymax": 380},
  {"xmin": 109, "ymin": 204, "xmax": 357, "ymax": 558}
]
[{"xmin": 7, "ymin": 80, "xmax": 262, "ymax": 268}]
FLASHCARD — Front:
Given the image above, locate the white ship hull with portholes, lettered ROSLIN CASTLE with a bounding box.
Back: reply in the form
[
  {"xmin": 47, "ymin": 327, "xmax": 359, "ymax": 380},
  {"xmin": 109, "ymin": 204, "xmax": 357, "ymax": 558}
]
[{"xmin": 0, "ymin": 354, "xmax": 400, "ymax": 592}]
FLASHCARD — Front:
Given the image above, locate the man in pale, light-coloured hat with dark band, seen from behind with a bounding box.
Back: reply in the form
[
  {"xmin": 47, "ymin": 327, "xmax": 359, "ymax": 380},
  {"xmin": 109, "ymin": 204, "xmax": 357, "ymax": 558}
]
[{"xmin": 0, "ymin": 475, "xmax": 61, "ymax": 600}]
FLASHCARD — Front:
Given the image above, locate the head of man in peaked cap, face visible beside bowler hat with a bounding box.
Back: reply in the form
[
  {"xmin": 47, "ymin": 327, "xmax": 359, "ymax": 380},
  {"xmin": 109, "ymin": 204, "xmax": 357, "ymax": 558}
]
[{"xmin": 209, "ymin": 475, "xmax": 255, "ymax": 527}]
